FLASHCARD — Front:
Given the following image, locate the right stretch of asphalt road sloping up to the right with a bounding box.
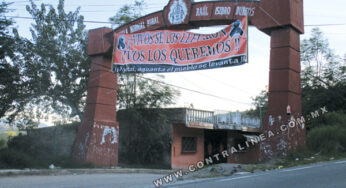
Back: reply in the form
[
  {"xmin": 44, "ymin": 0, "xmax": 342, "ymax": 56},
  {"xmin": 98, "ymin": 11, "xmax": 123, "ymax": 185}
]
[{"xmin": 165, "ymin": 160, "xmax": 346, "ymax": 188}]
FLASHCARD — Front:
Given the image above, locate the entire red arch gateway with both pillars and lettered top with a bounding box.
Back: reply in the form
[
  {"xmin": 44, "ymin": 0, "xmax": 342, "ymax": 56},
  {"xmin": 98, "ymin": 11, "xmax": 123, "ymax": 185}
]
[{"xmin": 73, "ymin": 0, "xmax": 305, "ymax": 166}]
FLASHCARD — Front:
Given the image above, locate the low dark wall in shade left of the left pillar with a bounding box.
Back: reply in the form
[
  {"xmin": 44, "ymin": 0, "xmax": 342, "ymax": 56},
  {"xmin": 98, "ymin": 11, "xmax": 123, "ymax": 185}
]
[{"xmin": 27, "ymin": 124, "xmax": 78, "ymax": 158}]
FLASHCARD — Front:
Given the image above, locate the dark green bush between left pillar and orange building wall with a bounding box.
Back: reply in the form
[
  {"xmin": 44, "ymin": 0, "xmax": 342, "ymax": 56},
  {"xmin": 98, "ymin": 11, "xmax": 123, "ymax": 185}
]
[{"xmin": 118, "ymin": 109, "xmax": 171, "ymax": 165}]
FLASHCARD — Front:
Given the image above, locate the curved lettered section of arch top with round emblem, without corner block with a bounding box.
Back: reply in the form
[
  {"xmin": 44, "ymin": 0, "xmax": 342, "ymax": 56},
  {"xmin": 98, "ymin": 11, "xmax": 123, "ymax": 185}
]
[{"xmin": 114, "ymin": 0, "xmax": 259, "ymax": 34}]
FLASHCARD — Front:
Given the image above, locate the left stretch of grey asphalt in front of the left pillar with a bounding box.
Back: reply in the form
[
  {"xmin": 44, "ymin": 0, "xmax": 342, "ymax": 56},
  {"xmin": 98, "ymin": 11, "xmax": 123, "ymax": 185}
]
[{"xmin": 0, "ymin": 173, "xmax": 163, "ymax": 188}]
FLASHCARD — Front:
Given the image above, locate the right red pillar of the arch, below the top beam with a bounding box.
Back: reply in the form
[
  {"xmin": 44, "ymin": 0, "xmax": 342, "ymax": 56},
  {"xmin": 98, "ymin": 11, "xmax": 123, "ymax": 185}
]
[{"xmin": 260, "ymin": 26, "xmax": 306, "ymax": 159}]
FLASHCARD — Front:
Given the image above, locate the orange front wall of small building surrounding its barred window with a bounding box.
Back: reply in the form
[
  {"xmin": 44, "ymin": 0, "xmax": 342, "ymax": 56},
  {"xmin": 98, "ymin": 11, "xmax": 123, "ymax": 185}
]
[{"xmin": 172, "ymin": 124, "xmax": 204, "ymax": 169}]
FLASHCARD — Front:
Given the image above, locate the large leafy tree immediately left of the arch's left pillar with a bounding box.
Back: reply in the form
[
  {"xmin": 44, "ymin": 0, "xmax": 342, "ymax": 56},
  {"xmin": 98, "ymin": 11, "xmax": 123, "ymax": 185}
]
[{"xmin": 13, "ymin": 0, "xmax": 90, "ymax": 119}]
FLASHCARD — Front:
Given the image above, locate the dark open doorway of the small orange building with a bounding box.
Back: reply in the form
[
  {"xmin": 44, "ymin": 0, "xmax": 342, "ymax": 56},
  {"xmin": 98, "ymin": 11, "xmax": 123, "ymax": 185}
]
[{"xmin": 204, "ymin": 130, "xmax": 227, "ymax": 163}]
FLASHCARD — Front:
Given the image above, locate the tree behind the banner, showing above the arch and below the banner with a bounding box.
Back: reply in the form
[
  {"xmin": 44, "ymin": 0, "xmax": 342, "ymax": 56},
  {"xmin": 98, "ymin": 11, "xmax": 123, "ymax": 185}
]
[{"xmin": 109, "ymin": 1, "xmax": 179, "ymax": 109}]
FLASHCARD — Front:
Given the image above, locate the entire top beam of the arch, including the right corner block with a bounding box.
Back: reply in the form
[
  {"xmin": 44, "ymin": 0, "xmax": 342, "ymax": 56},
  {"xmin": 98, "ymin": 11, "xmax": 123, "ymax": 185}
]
[{"xmin": 114, "ymin": 0, "xmax": 304, "ymax": 34}]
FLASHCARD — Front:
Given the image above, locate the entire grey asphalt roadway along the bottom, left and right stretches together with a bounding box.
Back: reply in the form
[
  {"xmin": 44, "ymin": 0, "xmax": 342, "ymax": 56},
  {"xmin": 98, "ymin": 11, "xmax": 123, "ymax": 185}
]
[{"xmin": 0, "ymin": 160, "xmax": 346, "ymax": 188}]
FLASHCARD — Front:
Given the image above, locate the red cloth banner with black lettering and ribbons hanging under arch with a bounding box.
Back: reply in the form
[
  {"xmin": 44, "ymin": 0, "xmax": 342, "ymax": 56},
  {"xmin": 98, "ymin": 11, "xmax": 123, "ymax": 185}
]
[{"xmin": 112, "ymin": 17, "xmax": 247, "ymax": 73}]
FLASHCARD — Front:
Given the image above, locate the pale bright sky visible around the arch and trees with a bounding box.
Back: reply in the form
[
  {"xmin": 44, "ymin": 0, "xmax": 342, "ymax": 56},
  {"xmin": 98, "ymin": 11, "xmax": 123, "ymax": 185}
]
[{"xmin": 6, "ymin": 0, "xmax": 346, "ymax": 115}]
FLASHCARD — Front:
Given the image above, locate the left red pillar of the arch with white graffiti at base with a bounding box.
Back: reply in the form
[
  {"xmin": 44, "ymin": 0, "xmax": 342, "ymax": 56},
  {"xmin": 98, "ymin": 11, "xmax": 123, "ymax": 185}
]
[{"xmin": 73, "ymin": 28, "xmax": 119, "ymax": 166}]
